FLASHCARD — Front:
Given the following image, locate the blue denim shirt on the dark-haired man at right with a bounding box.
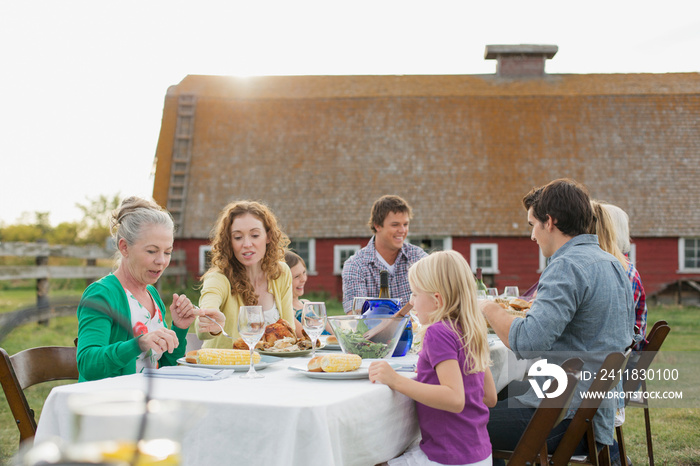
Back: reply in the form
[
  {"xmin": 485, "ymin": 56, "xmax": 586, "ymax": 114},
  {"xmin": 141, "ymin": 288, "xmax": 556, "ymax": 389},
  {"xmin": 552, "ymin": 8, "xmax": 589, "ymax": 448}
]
[{"xmin": 508, "ymin": 235, "xmax": 635, "ymax": 445}]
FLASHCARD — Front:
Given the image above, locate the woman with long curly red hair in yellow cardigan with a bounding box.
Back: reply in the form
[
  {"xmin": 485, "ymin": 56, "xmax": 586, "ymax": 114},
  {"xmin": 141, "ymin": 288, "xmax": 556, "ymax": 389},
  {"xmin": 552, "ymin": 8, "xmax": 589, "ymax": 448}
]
[{"xmin": 196, "ymin": 201, "xmax": 301, "ymax": 348}]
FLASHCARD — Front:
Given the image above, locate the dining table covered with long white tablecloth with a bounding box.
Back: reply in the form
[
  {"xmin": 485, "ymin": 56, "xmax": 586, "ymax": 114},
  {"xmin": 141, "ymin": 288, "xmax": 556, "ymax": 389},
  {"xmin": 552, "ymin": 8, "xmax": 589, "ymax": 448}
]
[{"xmin": 35, "ymin": 336, "xmax": 526, "ymax": 466}]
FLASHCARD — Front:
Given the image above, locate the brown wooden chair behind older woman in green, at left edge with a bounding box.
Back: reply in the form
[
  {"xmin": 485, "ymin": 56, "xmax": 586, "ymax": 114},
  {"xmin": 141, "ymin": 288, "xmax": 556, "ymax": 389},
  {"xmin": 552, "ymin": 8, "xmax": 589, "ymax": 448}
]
[{"xmin": 0, "ymin": 346, "xmax": 78, "ymax": 443}]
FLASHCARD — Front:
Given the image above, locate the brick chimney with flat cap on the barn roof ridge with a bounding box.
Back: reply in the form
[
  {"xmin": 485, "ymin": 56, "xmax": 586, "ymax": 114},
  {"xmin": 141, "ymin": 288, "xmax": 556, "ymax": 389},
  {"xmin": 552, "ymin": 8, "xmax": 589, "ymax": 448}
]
[{"xmin": 484, "ymin": 44, "xmax": 559, "ymax": 77}]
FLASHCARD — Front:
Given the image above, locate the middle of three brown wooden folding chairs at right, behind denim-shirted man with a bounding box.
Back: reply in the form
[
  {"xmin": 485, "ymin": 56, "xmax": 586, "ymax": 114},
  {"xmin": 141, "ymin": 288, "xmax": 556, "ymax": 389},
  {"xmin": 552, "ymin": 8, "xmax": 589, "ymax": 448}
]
[{"xmin": 549, "ymin": 349, "xmax": 632, "ymax": 466}]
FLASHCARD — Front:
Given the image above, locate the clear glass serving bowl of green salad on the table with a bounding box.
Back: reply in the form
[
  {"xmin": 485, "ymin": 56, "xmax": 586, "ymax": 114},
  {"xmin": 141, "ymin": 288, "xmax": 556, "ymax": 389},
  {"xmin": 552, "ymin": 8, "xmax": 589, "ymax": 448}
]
[{"xmin": 327, "ymin": 315, "xmax": 410, "ymax": 359}]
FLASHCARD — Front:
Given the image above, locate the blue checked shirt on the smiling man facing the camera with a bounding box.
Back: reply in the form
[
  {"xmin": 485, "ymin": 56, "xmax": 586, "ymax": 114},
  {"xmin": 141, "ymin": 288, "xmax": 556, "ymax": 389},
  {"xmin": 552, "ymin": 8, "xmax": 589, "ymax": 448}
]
[{"xmin": 343, "ymin": 236, "xmax": 428, "ymax": 313}]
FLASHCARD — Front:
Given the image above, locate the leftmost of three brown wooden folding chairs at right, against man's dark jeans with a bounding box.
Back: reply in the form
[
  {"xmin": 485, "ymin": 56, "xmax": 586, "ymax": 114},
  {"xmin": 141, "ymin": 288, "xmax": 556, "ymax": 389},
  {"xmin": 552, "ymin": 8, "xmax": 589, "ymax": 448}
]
[{"xmin": 492, "ymin": 358, "xmax": 583, "ymax": 466}]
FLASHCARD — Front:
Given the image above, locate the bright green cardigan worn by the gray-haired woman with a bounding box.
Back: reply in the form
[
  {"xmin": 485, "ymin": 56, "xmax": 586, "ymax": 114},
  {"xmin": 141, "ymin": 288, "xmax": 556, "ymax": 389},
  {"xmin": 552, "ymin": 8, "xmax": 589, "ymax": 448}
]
[{"xmin": 77, "ymin": 274, "xmax": 187, "ymax": 382}]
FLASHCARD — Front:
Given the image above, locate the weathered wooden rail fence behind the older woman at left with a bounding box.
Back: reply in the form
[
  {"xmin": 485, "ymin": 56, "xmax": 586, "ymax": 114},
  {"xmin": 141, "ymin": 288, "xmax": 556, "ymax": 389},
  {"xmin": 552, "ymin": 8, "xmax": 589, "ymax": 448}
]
[{"xmin": 0, "ymin": 241, "xmax": 187, "ymax": 339}]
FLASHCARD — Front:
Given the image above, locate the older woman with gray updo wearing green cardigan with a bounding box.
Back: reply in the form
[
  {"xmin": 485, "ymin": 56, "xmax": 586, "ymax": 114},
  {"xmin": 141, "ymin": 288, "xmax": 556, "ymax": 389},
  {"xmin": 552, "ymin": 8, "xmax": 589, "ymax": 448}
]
[{"xmin": 77, "ymin": 197, "xmax": 215, "ymax": 381}]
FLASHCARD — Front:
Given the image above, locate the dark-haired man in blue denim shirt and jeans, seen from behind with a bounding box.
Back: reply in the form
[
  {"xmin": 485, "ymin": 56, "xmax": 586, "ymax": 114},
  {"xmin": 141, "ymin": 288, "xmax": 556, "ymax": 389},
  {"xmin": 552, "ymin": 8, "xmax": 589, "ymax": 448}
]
[{"xmin": 481, "ymin": 179, "xmax": 634, "ymax": 462}]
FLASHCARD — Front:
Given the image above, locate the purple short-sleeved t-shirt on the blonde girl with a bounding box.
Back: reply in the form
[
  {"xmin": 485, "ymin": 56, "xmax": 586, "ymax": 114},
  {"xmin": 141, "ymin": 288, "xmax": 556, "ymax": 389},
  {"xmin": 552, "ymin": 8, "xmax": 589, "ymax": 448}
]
[{"xmin": 416, "ymin": 322, "xmax": 491, "ymax": 464}]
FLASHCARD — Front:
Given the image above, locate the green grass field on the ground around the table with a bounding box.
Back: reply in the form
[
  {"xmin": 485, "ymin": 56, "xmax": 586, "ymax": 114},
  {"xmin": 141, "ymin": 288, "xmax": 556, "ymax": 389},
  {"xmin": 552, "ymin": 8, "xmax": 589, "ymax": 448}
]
[{"xmin": 0, "ymin": 289, "xmax": 700, "ymax": 465}]
